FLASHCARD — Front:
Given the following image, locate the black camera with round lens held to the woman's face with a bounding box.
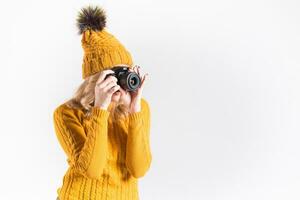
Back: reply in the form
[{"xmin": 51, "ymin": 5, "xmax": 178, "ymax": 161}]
[{"xmin": 106, "ymin": 66, "xmax": 141, "ymax": 92}]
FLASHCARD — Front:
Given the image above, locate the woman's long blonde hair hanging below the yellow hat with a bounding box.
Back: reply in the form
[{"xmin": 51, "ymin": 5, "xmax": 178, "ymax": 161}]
[{"xmin": 66, "ymin": 72, "xmax": 129, "ymax": 122}]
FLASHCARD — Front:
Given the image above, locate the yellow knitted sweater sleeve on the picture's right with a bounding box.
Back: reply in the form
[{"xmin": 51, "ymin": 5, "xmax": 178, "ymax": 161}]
[{"xmin": 126, "ymin": 98, "xmax": 152, "ymax": 178}]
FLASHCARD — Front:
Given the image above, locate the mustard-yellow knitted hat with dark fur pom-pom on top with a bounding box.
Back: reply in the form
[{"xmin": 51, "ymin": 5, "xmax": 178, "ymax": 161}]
[{"xmin": 77, "ymin": 5, "xmax": 133, "ymax": 79}]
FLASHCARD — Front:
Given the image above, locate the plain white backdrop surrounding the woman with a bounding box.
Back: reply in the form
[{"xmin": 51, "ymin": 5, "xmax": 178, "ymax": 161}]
[{"xmin": 0, "ymin": 0, "xmax": 300, "ymax": 200}]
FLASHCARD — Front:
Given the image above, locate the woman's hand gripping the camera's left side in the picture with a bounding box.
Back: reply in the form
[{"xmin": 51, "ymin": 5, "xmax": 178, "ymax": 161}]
[{"xmin": 94, "ymin": 69, "xmax": 120, "ymax": 110}]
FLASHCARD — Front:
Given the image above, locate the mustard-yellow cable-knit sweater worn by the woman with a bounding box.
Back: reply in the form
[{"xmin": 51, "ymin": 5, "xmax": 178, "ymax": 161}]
[{"xmin": 53, "ymin": 98, "xmax": 152, "ymax": 200}]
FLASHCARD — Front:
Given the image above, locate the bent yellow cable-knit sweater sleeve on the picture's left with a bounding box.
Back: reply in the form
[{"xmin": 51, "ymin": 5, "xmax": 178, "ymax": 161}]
[{"xmin": 53, "ymin": 107, "xmax": 110, "ymax": 180}]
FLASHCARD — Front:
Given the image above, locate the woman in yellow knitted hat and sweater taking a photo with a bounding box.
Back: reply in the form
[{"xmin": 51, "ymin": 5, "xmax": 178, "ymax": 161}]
[{"xmin": 53, "ymin": 6, "xmax": 152, "ymax": 200}]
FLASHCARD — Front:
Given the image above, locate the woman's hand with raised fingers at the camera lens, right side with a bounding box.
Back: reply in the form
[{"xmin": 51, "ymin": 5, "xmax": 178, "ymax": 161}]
[{"xmin": 129, "ymin": 65, "xmax": 149, "ymax": 113}]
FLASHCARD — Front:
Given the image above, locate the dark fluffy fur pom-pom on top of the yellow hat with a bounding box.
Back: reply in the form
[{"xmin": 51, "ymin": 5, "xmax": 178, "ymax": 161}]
[{"xmin": 77, "ymin": 5, "xmax": 106, "ymax": 34}]
